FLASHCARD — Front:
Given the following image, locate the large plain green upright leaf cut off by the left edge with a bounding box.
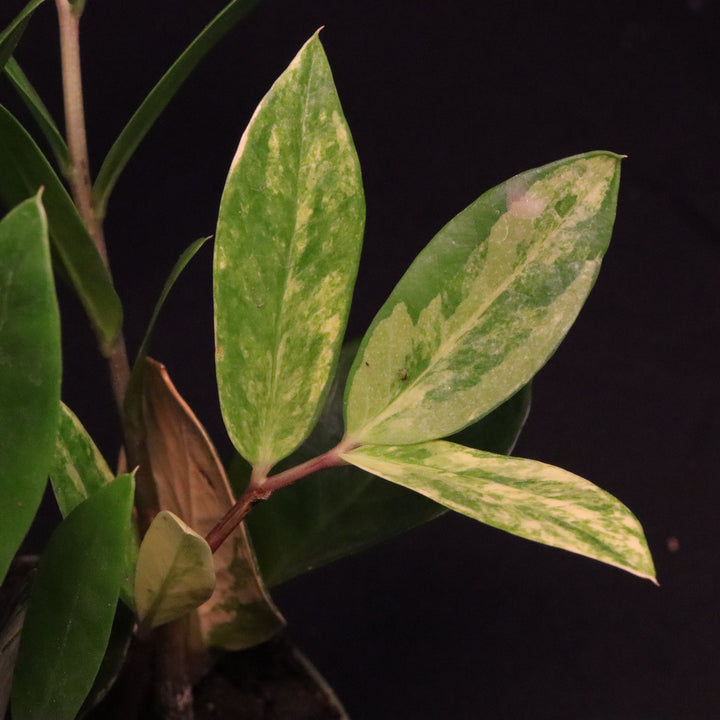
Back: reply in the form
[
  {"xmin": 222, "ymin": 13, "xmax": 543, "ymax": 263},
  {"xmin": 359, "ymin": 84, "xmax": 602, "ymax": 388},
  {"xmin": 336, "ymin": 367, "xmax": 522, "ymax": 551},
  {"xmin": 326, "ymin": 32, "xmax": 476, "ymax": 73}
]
[{"xmin": 0, "ymin": 195, "xmax": 61, "ymax": 582}]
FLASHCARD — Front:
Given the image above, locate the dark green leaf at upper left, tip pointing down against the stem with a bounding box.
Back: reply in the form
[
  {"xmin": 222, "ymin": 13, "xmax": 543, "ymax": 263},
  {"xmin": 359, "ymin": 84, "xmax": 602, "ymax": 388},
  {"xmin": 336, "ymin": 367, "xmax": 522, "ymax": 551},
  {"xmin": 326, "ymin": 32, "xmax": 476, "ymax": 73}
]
[{"xmin": 0, "ymin": 106, "xmax": 122, "ymax": 351}]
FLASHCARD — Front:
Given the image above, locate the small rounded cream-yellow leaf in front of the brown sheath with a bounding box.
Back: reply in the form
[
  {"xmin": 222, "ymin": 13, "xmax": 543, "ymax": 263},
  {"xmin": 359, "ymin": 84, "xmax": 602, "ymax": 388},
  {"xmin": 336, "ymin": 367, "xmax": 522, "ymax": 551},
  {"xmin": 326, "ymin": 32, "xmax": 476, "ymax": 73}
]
[{"xmin": 135, "ymin": 510, "xmax": 215, "ymax": 628}]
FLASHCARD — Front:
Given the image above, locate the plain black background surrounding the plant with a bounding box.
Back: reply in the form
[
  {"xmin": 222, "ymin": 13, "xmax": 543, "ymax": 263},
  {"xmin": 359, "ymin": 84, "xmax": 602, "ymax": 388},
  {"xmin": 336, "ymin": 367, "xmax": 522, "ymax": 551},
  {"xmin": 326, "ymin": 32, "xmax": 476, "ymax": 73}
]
[{"xmin": 5, "ymin": 0, "xmax": 720, "ymax": 720}]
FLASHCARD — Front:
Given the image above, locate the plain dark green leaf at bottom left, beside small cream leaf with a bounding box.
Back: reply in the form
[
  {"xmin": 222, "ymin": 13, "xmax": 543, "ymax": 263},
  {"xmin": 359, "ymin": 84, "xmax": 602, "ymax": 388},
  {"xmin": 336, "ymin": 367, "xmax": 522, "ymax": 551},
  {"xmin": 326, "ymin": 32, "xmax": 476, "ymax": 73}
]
[{"xmin": 11, "ymin": 475, "xmax": 135, "ymax": 720}]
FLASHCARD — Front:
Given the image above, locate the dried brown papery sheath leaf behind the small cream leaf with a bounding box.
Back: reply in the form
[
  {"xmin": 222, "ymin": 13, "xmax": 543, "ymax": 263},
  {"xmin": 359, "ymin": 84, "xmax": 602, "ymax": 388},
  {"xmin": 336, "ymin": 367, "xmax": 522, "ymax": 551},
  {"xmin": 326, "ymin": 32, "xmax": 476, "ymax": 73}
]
[{"xmin": 144, "ymin": 359, "xmax": 284, "ymax": 650}]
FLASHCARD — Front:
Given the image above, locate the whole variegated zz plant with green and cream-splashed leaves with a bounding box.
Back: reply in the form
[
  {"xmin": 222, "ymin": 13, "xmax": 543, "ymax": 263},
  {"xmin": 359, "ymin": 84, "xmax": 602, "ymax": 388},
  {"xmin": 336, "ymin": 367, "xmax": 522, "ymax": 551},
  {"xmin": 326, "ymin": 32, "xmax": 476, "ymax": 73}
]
[{"xmin": 0, "ymin": 0, "xmax": 654, "ymax": 720}]
